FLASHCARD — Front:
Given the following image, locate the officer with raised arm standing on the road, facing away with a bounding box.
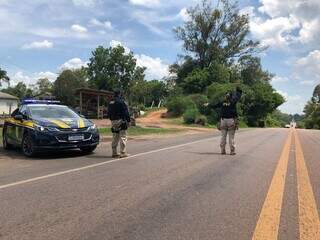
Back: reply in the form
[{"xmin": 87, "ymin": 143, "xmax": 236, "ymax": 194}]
[{"xmin": 206, "ymin": 87, "xmax": 242, "ymax": 155}]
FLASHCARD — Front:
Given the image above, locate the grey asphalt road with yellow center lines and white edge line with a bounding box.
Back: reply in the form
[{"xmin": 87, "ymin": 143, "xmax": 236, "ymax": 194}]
[{"xmin": 0, "ymin": 129, "xmax": 320, "ymax": 240}]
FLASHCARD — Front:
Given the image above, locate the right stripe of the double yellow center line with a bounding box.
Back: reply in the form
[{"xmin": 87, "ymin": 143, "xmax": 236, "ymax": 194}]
[{"xmin": 294, "ymin": 130, "xmax": 320, "ymax": 240}]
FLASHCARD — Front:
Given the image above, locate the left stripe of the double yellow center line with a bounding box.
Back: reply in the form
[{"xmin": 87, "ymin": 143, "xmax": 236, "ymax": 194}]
[{"xmin": 252, "ymin": 130, "xmax": 292, "ymax": 240}]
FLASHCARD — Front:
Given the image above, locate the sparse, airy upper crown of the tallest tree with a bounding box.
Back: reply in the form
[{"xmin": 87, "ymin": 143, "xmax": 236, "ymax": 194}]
[{"xmin": 174, "ymin": 0, "xmax": 259, "ymax": 68}]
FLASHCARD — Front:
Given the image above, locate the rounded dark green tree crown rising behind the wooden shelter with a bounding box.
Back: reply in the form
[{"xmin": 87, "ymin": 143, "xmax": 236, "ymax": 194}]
[{"xmin": 88, "ymin": 45, "xmax": 145, "ymax": 97}]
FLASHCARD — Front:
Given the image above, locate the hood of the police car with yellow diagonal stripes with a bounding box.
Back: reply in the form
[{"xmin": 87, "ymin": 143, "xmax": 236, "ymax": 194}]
[{"xmin": 34, "ymin": 118, "xmax": 93, "ymax": 129}]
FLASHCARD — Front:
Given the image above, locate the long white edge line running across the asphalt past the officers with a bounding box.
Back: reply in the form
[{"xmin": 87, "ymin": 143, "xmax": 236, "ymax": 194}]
[{"xmin": 0, "ymin": 137, "xmax": 216, "ymax": 190}]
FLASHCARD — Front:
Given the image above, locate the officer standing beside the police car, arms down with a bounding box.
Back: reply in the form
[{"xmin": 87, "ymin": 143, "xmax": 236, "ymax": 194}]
[{"xmin": 108, "ymin": 89, "xmax": 130, "ymax": 158}]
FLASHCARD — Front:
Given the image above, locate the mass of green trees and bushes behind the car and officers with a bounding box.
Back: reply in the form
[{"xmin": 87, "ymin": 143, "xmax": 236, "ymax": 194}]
[{"xmin": 0, "ymin": 0, "xmax": 300, "ymax": 129}]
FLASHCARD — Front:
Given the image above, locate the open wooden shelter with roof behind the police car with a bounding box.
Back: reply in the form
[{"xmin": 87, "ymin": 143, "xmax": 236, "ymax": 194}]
[{"xmin": 76, "ymin": 88, "xmax": 113, "ymax": 119}]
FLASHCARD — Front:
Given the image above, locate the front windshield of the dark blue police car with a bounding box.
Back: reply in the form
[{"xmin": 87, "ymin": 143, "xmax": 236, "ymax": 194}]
[{"xmin": 29, "ymin": 105, "xmax": 79, "ymax": 118}]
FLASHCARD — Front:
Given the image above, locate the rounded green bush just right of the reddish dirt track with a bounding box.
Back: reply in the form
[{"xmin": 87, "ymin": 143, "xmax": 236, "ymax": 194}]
[{"xmin": 166, "ymin": 96, "xmax": 197, "ymax": 117}]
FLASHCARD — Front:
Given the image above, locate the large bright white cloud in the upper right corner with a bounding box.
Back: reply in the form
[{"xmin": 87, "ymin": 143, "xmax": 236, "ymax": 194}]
[{"xmin": 251, "ymin": 0, "xmax": 320, "ymax": 48}]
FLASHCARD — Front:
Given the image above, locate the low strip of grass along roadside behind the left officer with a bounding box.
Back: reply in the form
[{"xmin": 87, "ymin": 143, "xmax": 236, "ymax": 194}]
[{"xmin": 99, "ymin": 127, "xmax": 184, "ymax": 136}]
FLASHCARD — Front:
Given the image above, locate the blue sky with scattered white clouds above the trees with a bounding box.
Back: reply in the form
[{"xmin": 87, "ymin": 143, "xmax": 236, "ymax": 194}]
[{"xmin": 0, "ymin": 0, "xmax": 320, "ymax": 113}]
